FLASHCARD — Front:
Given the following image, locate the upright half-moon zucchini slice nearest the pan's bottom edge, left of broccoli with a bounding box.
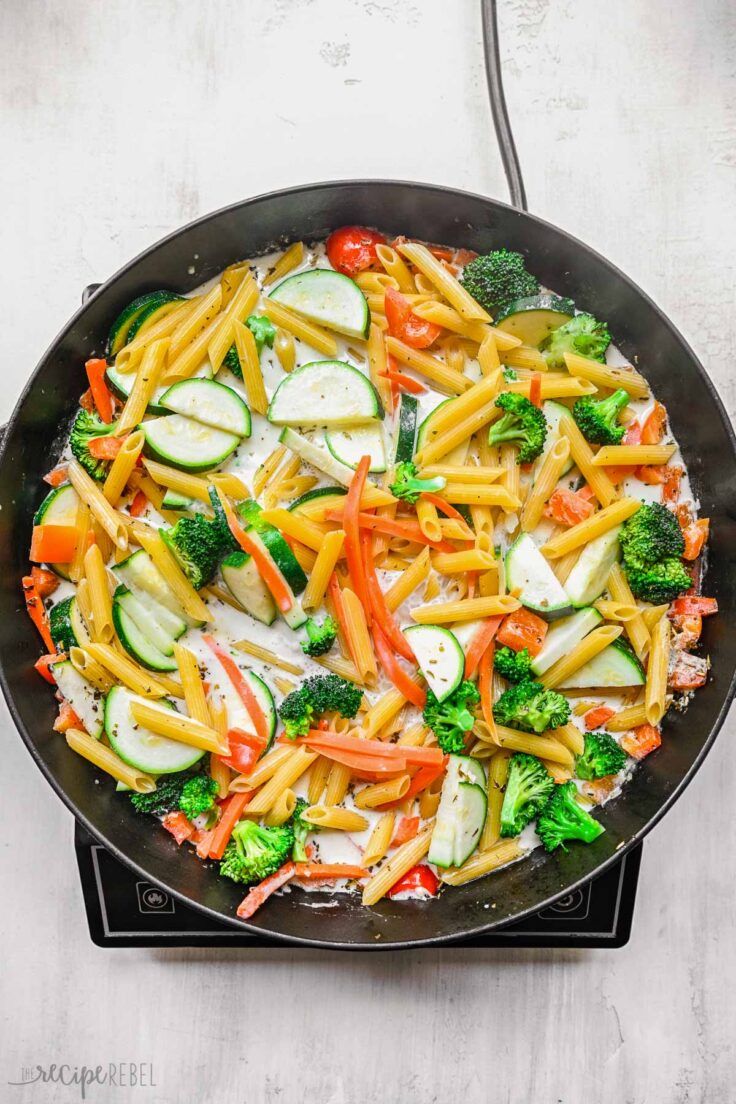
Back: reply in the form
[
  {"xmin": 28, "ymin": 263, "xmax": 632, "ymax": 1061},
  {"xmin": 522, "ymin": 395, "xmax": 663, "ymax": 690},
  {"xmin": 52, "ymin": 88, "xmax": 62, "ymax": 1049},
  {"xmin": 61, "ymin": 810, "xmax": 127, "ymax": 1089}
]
[{"xmin": 427, "ymin": 755, "xmax": 488, "ymax": 867}]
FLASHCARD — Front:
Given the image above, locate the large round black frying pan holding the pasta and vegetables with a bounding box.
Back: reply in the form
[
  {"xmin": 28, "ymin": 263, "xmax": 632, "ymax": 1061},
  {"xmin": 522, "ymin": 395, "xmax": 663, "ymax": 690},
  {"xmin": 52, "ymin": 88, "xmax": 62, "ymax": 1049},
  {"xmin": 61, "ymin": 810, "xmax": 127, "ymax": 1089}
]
[{"xmin": 0, "ymin": 180, "xmax": 736, "ymax": 948}]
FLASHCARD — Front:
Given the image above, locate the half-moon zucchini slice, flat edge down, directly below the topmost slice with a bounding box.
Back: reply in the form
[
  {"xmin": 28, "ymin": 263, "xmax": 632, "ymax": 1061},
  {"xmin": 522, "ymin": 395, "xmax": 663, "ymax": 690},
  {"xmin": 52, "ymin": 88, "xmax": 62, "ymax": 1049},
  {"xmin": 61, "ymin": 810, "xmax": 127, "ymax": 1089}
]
[{"xmin": 268, "ymin": 360, "xmax": 384, "ymax": 426}]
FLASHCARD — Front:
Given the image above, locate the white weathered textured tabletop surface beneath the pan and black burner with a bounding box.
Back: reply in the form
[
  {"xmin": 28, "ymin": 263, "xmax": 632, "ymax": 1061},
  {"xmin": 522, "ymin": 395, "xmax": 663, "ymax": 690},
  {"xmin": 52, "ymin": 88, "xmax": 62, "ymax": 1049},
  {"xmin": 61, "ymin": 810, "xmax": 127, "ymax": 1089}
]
[{"xmin": 0, "ymin": 0, "xmax": 736, "ymax": 1104}]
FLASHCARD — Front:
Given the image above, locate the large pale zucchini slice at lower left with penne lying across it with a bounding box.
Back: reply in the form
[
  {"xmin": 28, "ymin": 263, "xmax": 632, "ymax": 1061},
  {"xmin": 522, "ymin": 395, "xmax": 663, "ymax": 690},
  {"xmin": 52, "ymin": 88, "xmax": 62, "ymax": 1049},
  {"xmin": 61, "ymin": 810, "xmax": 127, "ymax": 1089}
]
[{"xmin": 105, "ymin": 687, "xmax": 204, "ymax": 775}]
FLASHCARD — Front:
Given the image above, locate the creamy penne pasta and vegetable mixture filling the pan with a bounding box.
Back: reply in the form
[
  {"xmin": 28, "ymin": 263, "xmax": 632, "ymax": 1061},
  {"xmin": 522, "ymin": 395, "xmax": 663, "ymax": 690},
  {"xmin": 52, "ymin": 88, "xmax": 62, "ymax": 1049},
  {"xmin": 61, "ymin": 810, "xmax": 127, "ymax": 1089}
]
[{"xmin": 23, "ymin": 226, "xmax": 717, "ymax": 917}]
